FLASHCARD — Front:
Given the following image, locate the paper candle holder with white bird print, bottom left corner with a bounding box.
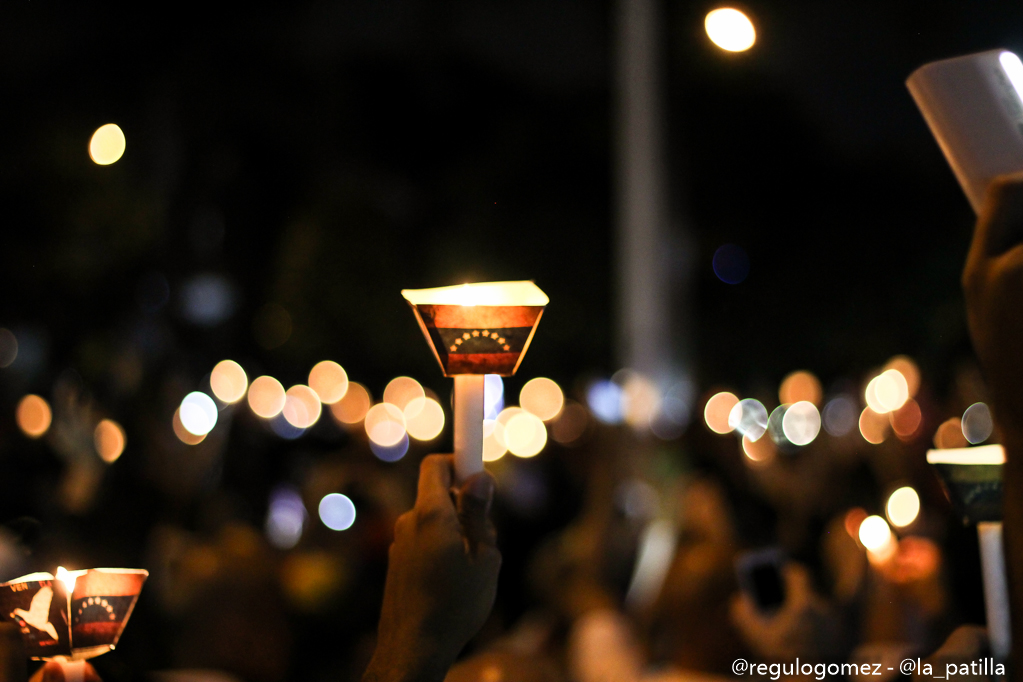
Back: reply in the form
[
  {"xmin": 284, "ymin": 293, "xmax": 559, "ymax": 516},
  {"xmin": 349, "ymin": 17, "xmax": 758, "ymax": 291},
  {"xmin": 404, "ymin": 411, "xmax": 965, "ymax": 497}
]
[{"xmin": 0, "ymin": 569, "xmax": 149, "ymax": 661}]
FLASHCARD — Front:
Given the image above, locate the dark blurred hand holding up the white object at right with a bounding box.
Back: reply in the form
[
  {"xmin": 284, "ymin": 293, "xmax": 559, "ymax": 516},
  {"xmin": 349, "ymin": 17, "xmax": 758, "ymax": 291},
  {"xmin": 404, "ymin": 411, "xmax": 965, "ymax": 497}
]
[{"xmin": 963, "ymin": 174, "xmax": 1023, "ymax": 441}]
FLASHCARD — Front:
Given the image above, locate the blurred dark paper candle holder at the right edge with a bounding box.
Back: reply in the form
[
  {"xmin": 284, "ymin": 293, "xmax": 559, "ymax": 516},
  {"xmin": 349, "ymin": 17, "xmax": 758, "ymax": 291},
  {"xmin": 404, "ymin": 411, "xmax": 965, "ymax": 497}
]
[{"xmin": 927, "ymin": 445, "xmax": 1006, "ymax": 524}]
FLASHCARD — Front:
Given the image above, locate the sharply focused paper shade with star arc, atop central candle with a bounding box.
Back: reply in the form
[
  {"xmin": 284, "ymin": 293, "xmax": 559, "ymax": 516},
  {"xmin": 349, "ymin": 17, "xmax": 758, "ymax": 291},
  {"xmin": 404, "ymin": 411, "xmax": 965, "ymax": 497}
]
[{"xmin": 401, "ymin": 281, "xmax": 548, "ymax": 376}]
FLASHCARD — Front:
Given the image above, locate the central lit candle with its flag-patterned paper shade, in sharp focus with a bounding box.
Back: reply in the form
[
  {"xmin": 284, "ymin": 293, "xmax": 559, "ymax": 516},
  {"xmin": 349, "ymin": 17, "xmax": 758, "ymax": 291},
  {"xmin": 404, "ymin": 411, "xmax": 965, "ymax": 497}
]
[{"xmin": 401, "ymin": 281, "xmax": 549, "ymax": 481}]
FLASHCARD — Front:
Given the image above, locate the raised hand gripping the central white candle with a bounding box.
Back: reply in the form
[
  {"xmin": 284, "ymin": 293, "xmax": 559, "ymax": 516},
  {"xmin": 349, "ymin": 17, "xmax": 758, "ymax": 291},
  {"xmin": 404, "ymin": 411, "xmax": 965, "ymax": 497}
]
[{"xmin": 363, "ymin": 455, "xmax": 501, "ymax": 682}]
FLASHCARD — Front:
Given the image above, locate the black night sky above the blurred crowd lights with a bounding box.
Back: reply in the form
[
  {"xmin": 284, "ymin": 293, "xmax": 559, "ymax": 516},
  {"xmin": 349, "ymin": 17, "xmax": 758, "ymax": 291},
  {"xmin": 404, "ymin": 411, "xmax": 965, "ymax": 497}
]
[{"xmin": 0, "ymin": 1, "xmax": 1023, "ymax": 408}]
